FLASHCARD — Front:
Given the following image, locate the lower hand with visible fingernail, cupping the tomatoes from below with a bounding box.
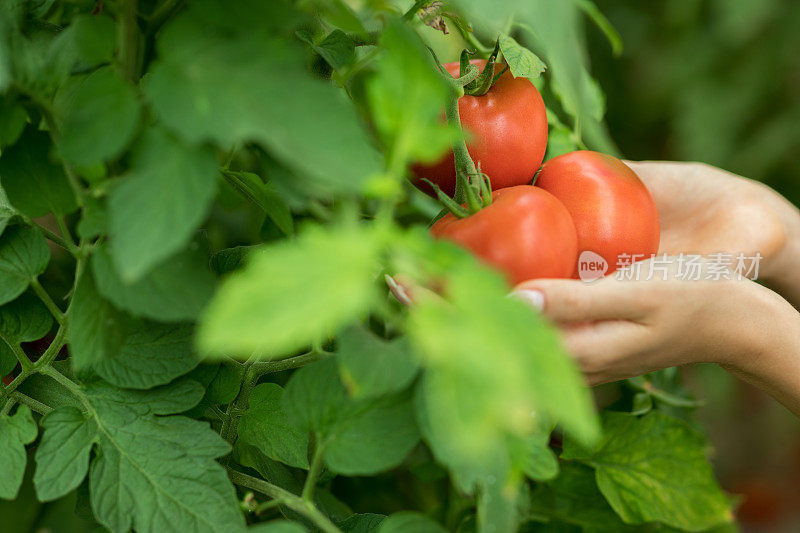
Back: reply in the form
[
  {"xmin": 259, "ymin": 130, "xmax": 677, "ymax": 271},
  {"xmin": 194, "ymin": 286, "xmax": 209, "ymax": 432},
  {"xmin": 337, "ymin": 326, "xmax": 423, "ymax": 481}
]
[{"xmin": 514, "ymin": 260, "xmax": 800, "ymax": 386}]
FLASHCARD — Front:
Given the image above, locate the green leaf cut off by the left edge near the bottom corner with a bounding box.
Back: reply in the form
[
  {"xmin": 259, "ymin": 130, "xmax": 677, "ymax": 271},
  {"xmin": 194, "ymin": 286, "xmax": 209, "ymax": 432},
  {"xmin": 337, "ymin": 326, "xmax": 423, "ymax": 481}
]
[{"xmin": 0, "ymin": 405, "xmax": 38, "ymax": 500}]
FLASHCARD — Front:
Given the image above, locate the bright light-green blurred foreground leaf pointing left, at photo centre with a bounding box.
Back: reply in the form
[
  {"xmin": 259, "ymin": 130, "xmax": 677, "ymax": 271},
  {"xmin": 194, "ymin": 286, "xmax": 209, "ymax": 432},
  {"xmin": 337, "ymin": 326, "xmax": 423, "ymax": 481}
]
[{"xmin": 198, "ymin": 227, "xmax": 379, "ymax": 358}]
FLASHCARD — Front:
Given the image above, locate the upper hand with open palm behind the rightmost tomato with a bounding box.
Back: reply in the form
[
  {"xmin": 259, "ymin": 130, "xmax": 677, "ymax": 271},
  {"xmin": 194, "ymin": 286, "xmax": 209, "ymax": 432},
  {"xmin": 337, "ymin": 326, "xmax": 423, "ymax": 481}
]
[{"xmin": 626, "ymin": 161, "xmax": 800, "ymax": 304}]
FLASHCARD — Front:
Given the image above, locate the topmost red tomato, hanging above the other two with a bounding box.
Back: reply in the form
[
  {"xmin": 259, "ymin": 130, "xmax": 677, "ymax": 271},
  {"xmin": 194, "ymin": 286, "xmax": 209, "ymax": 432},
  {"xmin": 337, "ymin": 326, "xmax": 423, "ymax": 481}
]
[{"xmin": 413, "ymin": 59, "xmax": 547, "ymax": 196}]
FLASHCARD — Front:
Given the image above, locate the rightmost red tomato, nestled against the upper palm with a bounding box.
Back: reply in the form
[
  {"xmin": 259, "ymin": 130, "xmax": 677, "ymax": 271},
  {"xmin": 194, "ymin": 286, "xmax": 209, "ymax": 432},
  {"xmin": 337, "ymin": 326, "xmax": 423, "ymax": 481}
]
[{"xmin": 536, "ymin": 151, "xmax": 660, "ymax": 276}]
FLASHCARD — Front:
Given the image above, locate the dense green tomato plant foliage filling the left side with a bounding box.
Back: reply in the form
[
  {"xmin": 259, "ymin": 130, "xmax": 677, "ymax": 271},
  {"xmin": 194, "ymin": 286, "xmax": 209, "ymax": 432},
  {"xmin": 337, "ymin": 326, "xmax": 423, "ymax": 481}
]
[{"xmin": 0, "ymin": 0, "xmax": 732, "ymax": 533}]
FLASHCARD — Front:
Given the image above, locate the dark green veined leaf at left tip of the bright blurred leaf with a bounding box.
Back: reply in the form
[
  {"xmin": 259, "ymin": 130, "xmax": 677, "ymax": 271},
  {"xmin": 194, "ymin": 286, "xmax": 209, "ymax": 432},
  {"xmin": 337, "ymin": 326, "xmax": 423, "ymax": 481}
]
[{"xmin": 93, "ymin": 320, "xmax": 200, "ymax": 389}]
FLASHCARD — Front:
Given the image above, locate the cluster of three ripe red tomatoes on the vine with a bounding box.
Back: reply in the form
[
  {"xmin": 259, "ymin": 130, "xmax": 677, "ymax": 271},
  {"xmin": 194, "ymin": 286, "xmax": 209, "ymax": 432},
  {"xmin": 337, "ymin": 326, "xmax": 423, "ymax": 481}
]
[{"xmin": 414, "ymin": 59, "xmax": 660, "ymax": 284}]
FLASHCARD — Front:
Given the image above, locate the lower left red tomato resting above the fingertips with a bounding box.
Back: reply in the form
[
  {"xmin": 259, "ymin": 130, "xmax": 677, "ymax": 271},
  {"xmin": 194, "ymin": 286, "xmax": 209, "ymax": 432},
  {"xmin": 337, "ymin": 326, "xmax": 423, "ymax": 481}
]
[{"xmin": 431, "ymin": 185, "xmax": 578, "ymax": 285}]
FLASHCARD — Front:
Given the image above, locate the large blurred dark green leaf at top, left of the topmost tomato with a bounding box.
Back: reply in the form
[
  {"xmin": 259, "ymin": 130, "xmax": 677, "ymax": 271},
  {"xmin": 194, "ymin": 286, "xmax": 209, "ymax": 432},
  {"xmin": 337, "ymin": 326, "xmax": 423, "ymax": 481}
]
[{"xmin": 144, "ymin": 0, "xmax": 381, "ymax": 192}]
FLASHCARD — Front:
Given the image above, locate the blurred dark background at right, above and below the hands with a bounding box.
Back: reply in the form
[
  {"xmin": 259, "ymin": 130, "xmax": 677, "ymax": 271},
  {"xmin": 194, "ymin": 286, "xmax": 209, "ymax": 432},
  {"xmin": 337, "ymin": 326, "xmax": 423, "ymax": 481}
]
[{"xmin": 587, "ymin": 0, "xmax": 800, "ymax": 532}]
